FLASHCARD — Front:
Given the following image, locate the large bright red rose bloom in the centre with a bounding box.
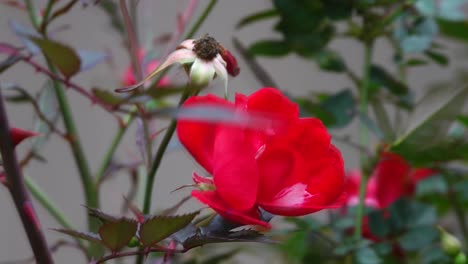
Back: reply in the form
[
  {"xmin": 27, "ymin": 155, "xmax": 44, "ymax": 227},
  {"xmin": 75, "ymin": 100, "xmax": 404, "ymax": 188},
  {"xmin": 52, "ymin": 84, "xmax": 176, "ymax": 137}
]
[{"xmin": 177, "ymin": 88, "xmax": 344, "ymax": 227}]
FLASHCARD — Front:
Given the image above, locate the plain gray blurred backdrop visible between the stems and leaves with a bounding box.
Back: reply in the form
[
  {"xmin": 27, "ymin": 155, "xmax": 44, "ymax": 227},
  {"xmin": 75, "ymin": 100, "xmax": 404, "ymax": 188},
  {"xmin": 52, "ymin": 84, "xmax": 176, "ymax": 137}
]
[{"xmin": 0, "ymin": 0, "xmax": 466, "ymax": 264}]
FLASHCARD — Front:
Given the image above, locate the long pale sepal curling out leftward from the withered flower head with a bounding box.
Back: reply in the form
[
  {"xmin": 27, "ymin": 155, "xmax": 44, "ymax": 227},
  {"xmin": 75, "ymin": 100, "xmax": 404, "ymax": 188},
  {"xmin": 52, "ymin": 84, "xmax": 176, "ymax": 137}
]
[{"xmin": 115, "ymin": 49, "xmax": 197, "ymax": 93}]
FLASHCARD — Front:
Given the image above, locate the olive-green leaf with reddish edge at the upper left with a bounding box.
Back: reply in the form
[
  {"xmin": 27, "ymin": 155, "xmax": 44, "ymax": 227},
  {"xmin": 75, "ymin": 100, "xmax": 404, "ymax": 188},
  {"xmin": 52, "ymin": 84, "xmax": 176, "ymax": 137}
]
[{"xmin": 30, "ymin": 37, "xmax": 81, "ymax": 78}]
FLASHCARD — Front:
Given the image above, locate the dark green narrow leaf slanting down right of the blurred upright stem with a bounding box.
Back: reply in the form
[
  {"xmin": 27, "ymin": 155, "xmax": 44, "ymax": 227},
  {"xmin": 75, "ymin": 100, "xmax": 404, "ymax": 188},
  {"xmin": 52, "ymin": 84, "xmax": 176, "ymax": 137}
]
[{"xmin": 369, "ymin": 65, "xmax": 409, "ymax": 95}]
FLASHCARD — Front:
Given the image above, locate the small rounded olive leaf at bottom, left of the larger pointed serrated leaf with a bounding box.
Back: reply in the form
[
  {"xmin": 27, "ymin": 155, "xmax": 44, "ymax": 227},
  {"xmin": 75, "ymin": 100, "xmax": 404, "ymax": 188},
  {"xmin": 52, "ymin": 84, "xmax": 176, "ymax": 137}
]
[{"xmin": 99, "ymin": 218, "xmax": 138, "ymax": 252}]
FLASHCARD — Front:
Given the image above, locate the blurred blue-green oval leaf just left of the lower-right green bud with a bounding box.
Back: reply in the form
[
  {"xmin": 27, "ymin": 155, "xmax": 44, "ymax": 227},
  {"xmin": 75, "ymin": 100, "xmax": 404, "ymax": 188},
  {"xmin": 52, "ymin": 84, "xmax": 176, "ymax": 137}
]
[{"xmin": 398, "ymin": 226, "xmax": 439, "ymax": 251}]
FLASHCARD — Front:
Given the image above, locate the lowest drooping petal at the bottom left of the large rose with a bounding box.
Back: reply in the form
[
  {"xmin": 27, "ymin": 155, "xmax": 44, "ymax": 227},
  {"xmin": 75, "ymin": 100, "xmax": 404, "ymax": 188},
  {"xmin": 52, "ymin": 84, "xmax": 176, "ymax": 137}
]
[{"xmin": 192, "ymin": 190, "xmax": 271, "ymax": 228}]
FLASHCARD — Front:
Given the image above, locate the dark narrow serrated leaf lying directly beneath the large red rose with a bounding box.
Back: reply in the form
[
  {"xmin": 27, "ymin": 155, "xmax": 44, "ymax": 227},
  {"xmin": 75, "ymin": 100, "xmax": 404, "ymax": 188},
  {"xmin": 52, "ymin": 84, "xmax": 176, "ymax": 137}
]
[{"xmin": 183, "ymin": 229, "xmax": 276, "ymax": 249}]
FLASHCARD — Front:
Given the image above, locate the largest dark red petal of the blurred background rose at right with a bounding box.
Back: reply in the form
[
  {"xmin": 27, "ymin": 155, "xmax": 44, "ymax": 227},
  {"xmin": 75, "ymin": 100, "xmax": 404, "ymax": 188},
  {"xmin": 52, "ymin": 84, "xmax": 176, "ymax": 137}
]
[{"xmin": 372, "ymin": 152, "xmax": 410, "ymax": 208}]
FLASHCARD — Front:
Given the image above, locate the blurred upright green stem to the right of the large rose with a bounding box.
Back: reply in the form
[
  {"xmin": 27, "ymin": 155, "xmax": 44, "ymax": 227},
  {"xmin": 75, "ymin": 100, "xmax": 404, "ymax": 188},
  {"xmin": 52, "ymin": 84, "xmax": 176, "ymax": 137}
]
[{"xmin": 354, "ymin": 41, "xmax": 373, "ymax": 240}]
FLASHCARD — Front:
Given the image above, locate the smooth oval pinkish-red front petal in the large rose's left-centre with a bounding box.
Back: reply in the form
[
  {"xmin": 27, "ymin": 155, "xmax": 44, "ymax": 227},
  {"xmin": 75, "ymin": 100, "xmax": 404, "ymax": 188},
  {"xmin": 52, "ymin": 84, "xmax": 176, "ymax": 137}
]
[{"xmin": 213, "ymin": 126, "xmax": 259, "ymax": 210}]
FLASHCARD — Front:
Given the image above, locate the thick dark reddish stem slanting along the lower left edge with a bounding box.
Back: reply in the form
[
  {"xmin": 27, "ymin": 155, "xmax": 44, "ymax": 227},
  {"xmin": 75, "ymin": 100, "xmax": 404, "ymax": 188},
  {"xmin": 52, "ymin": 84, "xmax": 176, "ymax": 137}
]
[{"xmin": 0, "ymin": 88, "xmax": 54, "ymax": 264}]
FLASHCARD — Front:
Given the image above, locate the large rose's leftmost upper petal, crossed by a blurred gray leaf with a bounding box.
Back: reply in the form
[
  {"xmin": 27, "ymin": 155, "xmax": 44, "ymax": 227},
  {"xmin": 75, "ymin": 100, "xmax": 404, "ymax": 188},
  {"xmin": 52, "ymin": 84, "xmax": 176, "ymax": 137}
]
[{"xmin": 177, "ymin": 95, "xmax": 234, "ymax": 174}]
